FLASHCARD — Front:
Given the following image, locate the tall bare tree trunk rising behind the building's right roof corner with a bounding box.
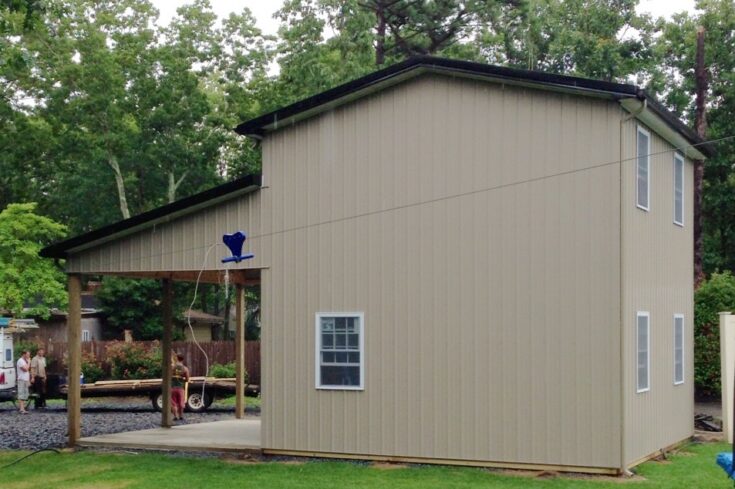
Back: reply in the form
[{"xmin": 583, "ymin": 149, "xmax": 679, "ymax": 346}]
[{"xmin": 693, "ymin": 26, "xmax": 707, "ymax": 290}]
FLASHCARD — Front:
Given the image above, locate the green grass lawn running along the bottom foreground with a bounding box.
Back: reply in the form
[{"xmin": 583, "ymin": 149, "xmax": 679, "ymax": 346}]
[{"xmin": 0, "ymin": 443, "xmax": 732, "ymax": 489}]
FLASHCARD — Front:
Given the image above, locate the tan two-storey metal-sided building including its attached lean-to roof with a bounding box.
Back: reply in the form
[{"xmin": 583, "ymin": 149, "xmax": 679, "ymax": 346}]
[{"xmin": 42, "ymin": 58, "xmax": 710, "ymax": 472}]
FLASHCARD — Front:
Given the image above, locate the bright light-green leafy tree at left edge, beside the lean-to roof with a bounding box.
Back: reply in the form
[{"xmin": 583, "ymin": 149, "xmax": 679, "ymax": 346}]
[{"xmin": 0, "ymin": 204, "xmax": 68, "ymax": 318}]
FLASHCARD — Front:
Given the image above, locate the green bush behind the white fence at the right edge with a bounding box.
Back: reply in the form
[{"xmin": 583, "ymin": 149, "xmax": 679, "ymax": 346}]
[{"xmin": 694, "ymin": 272, "xmax": 735, "ymax": 396}]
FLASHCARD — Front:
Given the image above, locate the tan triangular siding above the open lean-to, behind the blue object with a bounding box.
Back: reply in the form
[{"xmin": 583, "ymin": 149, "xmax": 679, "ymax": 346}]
[{"xmin": 66, "ymin": 192, "xmax": 267, "ymax": 273}]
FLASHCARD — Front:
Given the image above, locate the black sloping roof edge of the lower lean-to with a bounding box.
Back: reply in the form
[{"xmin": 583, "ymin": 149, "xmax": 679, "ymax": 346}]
[{"xmin": 39, "ymin": 175, "xmax": 262, "ymax": 258}]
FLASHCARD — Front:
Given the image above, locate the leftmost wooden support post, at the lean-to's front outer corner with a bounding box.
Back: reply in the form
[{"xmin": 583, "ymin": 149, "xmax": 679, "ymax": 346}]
[{"xmin": 66, "ymin": 274, "xmax": 82, "ymax": 447}]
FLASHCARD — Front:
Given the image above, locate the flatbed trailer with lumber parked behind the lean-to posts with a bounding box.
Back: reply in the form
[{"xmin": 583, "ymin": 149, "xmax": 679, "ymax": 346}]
[{"xmin": 57, "ymin": 377, "xmax": 260, "ymax": 413}]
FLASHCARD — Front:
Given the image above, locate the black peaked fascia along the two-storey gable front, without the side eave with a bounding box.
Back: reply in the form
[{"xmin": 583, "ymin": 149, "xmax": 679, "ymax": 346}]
[{"xmin": 235, "ymin": 56, "xmax": 640, "ymax": 137}]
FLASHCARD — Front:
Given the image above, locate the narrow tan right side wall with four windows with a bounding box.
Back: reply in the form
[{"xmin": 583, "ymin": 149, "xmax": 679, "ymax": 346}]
[{"xmin": 622, "ymin": 121, "xmax": 694, "ymax": 463}]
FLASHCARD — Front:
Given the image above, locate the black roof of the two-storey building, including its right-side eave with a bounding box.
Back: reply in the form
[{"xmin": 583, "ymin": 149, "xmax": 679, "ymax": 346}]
[{"xmin": 235, "ymin": 56, "xmax": 712, "ymax": 156}]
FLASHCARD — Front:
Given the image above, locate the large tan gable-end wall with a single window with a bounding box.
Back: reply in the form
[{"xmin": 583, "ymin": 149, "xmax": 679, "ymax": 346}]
[{"xmin": 261, "ymin": 76, "xmax": 621, "ymax": 467}]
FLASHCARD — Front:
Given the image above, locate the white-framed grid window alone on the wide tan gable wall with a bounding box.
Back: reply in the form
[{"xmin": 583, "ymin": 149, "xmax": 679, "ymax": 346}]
[{"xmin": 316, "ymin": 312, "xmax": 365, "ymax": 390}]
